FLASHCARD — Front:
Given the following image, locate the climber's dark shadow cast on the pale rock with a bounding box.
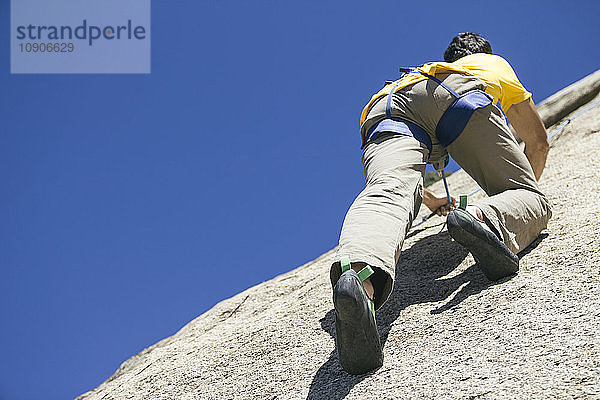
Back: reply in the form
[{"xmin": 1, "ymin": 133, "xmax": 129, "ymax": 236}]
[{"xmin": 307, "ymin": 232, "xmax": 504, "ymax": 400}]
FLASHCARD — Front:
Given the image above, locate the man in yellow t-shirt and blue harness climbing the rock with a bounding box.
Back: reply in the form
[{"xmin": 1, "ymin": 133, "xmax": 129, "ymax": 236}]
[{"xmin": 330, "ymin": 32, "xmax": 551, "ymax": 374}]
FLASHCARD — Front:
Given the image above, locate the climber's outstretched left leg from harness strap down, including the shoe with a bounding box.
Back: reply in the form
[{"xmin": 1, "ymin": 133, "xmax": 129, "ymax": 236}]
[{"xmin": 330, "ymin": 135, "xmax": 428, "ymax": 374}]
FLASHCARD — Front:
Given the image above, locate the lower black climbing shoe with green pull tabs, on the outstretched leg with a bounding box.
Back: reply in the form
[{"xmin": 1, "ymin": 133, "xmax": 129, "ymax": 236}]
[{"xmin": 333, "ymin": 259, "xmax": 383, "ymax": 375}]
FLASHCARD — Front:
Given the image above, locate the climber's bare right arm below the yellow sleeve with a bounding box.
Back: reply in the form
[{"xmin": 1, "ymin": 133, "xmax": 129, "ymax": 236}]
[{"xmin": 506, "ymin": 98, "xmax": 550, "ymax": 180}]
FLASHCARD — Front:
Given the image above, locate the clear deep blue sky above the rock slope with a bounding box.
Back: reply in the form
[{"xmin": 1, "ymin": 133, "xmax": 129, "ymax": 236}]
[{"xmin": 0, "ymin": 0, "xmax": 600, "ymax": 400}]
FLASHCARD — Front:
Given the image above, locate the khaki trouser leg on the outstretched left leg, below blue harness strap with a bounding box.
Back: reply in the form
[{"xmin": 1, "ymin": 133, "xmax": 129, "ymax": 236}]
[{"xmin": 331, "ymin": 135, "xmax": 428, "ymax": 308}]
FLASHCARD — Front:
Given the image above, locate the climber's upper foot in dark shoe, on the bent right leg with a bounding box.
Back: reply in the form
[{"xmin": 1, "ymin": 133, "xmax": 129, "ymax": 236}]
[{"xmin": 446, "ymin": 209, "xmax": 519, "ymax": 281}]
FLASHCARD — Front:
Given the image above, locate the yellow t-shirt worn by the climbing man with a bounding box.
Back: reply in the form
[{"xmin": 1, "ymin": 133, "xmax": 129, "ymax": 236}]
[{"xmin": 360, "ymin": 53, "xmax": 531, "ymax": 125}]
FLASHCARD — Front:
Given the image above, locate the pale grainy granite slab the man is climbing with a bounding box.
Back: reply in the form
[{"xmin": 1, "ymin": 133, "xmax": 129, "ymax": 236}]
[{"xmin": 78, "ymin": 73, "xmax": 600, "ymax": 400}]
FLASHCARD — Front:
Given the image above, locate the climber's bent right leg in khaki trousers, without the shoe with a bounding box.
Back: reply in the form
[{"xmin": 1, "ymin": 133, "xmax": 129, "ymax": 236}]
[{"xmin": 448, "ymin": 106, "xmax": 552, "ymax": 262}]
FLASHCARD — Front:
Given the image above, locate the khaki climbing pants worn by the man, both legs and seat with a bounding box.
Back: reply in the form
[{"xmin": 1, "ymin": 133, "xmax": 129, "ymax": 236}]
[{"xmin": 330, "ymin": 74, "xmax": 552, "ymax": 308}]
